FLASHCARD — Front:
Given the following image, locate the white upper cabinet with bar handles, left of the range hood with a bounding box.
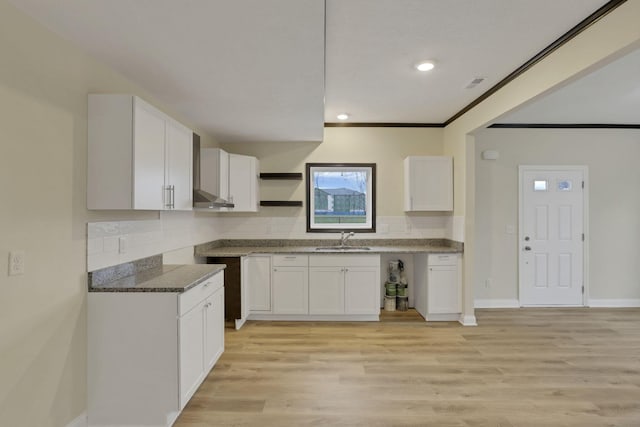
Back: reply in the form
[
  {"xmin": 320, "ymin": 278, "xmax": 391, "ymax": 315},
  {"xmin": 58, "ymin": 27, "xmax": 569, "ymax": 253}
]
[{"xmin": 87, "ymin": 94, "xmax": 193, "ymax": 210}]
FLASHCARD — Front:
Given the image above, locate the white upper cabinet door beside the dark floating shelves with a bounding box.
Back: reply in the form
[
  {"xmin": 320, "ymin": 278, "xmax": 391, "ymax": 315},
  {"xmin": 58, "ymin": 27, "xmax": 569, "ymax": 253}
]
[{"xmin": 229, "ymin": 154, "xmax": 258, "ymax": 212}]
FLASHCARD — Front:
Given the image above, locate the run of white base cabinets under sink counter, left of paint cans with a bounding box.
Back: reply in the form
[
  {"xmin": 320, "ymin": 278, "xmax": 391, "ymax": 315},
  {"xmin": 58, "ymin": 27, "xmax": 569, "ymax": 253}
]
[{"xmin": 248, "ymin": 254, "xmax": 380, "ymax": 321}]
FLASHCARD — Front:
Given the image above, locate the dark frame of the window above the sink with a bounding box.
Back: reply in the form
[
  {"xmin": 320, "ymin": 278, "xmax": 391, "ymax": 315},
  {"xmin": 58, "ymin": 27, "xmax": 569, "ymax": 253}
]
[{"xmin": 305, "ymin": 163, "xmax": 376, "ymax": 233}]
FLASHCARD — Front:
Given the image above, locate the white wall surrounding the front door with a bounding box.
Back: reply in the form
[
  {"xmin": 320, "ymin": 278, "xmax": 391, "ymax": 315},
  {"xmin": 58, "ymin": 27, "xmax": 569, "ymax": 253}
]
[{"xmin": 473, "ymin": 129, "xmax": 640, "ymax": 305}]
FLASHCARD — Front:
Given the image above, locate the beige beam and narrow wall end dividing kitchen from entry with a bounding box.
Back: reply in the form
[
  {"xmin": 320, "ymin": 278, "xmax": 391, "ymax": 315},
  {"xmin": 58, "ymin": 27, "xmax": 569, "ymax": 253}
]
[{"xmin": 444, "ymin": 1, "xmax": 640, "ymax": 319}]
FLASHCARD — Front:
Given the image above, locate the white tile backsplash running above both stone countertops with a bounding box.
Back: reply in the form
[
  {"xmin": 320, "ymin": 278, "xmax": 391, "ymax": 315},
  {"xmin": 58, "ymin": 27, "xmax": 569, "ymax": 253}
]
[{"xmin": 87, "ymin": 211, "xmax": 464, "ymax": 271}]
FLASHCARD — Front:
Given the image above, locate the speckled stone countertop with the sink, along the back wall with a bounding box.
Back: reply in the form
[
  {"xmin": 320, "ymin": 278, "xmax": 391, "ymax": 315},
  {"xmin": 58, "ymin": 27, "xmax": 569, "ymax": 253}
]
[{"xmin": 195, "ymin": 239, "xmax": 463, "ymax": 257}]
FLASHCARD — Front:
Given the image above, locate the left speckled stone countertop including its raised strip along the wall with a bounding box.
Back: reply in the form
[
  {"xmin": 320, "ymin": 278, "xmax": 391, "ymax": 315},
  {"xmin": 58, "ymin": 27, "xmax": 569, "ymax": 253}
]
[{"xmin": 89, "ymin": 254, "xmax": 226, "ymax": 292}]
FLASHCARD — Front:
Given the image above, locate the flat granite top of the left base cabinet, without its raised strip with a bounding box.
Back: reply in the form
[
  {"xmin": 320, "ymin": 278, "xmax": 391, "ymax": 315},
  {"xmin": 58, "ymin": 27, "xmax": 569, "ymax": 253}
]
[{"xmin": 89, "ymin": 264, "xmax": 226, "ymax": 292}]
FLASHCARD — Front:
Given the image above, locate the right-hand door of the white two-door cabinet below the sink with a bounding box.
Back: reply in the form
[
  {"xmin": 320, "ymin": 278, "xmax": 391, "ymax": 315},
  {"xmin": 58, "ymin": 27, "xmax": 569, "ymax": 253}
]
[{"xmin": 344, "ymin": 267, "xmax": 380, "ymax": 314}]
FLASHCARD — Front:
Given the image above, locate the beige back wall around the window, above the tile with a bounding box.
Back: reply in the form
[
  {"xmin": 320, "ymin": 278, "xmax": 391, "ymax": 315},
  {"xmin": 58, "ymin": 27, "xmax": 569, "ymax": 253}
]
[{"xmin": 223, "ymin": 127, "xmax": 443, "ymax": 216}]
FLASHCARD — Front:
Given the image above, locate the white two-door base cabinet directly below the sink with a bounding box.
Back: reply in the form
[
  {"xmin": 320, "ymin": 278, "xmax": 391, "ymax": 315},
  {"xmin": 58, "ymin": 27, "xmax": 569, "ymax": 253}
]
[{"xmin": 309, "ymin": 255, "xmax": 380, "ymax": 316}]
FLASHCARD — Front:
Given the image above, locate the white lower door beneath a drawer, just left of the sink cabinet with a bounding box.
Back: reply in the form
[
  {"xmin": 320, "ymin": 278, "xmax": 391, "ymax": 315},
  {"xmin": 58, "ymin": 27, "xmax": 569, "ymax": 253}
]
[{"xmin": 271, "ymin": 267, "xmax": 309, "ymax": 314}]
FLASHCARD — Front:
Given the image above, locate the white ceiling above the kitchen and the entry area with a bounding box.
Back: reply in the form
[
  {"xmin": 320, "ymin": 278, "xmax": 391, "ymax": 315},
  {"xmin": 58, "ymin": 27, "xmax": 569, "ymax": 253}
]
[{"xmin": 11, "ymin": 0, "xmax": 640, "ymax": 142}]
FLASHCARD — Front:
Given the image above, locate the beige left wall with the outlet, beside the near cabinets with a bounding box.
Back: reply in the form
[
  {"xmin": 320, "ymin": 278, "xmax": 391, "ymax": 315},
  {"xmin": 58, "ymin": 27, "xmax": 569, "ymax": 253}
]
[{"xmin": 0, "ymin": 0, "xmax": 213, "ymax": 427}]
